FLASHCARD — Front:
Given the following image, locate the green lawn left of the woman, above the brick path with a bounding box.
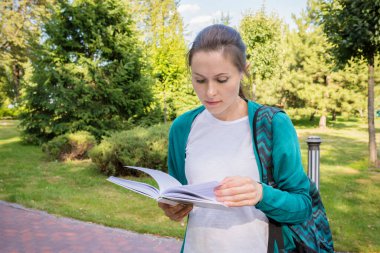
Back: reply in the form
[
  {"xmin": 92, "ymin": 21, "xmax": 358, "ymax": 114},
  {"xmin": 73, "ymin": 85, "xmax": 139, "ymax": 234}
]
[{"xmin": 0, "ymin": 121, "xmax": 184, "ymax": 238}]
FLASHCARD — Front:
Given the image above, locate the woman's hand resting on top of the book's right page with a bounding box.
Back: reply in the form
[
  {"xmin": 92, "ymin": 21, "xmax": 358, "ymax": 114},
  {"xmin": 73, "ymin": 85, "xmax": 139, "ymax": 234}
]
[{"xmin": 214, "ymin": 177, "xmax": 263, "ymax": 207}]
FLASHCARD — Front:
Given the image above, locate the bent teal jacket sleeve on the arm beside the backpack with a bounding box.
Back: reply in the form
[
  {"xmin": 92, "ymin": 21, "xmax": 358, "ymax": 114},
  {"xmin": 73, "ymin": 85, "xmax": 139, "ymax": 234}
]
[{"xmin": 256, "ymin": 113, "xmax": 312, "ymax": 224}]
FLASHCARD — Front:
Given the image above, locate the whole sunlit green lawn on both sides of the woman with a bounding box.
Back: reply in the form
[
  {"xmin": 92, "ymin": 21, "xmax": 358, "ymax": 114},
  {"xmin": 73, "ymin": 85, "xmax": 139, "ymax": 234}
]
[{"xmin": 0, "ymin": 119, "xmax": 380, "ymax": 252}]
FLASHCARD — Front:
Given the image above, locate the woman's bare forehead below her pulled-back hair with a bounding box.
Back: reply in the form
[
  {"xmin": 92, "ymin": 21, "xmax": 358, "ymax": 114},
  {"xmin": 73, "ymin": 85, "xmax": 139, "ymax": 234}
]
[{"xmin": 190, "ymin": 50, "xmax": 239, "ymax": 74}]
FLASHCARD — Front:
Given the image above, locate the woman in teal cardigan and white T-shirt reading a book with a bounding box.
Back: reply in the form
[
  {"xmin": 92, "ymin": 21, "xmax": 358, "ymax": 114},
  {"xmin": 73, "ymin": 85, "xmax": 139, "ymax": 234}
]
[{"xmin": 159, "ymin": 25, "xmax": 311, "ymax": 253}]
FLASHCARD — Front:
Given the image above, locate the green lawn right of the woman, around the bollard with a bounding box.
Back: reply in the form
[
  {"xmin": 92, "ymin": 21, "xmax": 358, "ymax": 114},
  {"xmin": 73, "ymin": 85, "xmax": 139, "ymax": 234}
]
[{"xmin": 297, "ymin": 117, "xmax": 380, "ymax": 252}]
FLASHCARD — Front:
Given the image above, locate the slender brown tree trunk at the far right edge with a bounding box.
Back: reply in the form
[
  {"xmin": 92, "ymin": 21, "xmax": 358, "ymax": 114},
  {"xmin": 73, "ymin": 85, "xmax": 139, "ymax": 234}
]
[{"xmin": 368, "ymin": 55, "xmax": 377, "ymax": 166}]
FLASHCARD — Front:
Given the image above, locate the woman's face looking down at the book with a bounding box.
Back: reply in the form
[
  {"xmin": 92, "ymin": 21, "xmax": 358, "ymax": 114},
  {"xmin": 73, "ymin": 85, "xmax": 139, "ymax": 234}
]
[{"xmin": 190, "ymin": 51, "xmax": 246, "ymax": 121}]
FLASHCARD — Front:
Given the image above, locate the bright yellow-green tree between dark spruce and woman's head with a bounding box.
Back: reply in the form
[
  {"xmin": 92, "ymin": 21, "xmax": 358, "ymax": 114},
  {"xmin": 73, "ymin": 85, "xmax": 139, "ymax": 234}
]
[{"xmin": 132, "ymin": 0, "xmax": 198, "ymax": 122}]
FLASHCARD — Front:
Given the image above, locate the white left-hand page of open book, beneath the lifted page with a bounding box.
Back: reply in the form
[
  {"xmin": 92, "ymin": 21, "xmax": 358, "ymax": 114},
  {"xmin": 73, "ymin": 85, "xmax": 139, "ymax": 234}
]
[{"xmin": 107, "ymin": 177, "xmax": 160, "ymax": 200}]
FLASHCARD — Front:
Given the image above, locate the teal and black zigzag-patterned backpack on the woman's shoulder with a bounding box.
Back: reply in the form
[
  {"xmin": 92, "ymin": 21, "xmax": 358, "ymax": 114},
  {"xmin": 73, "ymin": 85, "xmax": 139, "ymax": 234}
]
[{"xmin": 253, "ymin": 106, "xmax": 334, "ymax": 253}]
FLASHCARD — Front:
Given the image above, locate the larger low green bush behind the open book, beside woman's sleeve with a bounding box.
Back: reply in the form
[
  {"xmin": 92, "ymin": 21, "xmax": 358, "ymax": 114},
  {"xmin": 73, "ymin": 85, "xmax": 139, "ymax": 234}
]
[{"xmin": 90, "ymin": 124, "xmax": 169, "ymax": 176}]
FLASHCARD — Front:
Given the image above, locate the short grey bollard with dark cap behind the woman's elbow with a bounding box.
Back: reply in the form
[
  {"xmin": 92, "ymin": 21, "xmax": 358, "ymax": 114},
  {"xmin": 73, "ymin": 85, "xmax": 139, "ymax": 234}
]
[{"xmin": 306, "ymin": 136, "xmax": 322, "ymax": 189}]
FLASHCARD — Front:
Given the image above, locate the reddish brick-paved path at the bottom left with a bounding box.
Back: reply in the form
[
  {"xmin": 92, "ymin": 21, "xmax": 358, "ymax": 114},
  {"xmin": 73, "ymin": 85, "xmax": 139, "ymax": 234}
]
[{"xmin": 0, "ymin": 201, "xmax": 182, "ymax": 253}]
